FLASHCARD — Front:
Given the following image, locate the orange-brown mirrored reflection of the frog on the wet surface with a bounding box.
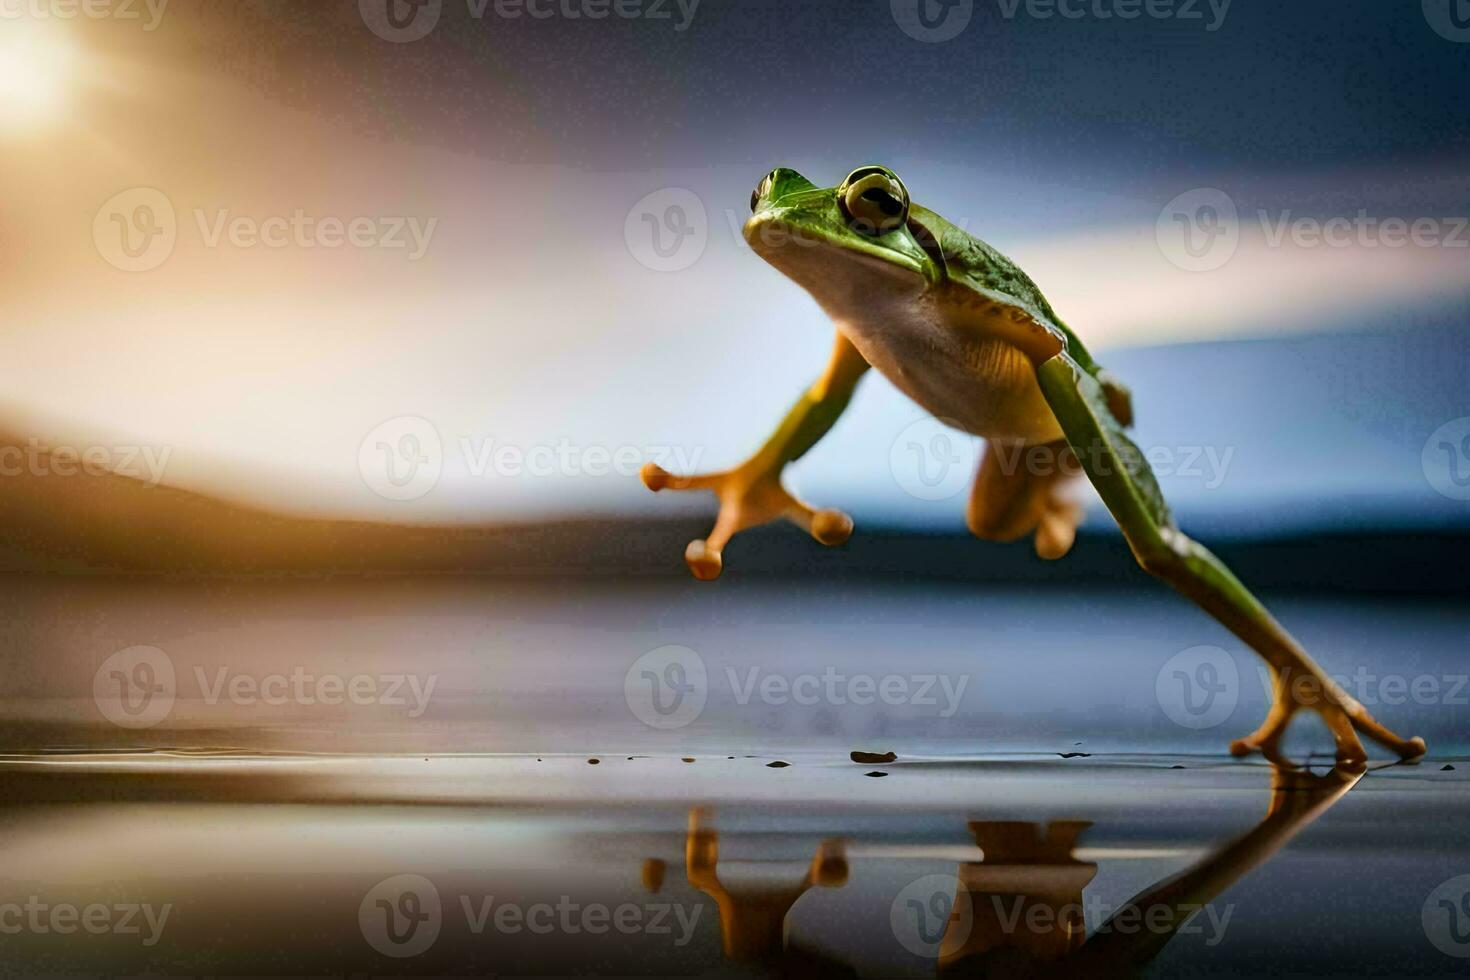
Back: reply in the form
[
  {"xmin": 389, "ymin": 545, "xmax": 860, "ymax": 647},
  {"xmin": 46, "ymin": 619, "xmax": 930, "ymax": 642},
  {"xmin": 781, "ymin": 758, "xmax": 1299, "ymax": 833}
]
[{"xmin": 644, "ymin": 768, "xmax": 1361, "ymax": 977}]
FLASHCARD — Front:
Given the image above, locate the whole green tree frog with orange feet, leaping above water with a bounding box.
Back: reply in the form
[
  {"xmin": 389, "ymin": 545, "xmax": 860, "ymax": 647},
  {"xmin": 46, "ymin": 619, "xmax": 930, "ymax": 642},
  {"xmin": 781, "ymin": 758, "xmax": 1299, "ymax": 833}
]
[{"xmin": 639, "ymin": 165, "xmax": 1427, "ymax": 768}]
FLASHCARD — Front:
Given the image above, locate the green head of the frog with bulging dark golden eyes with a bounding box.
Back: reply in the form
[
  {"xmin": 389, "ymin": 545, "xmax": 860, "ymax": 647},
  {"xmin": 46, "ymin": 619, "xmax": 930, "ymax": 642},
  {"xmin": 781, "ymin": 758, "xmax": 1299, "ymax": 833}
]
[{"xmin": 745, "ymin": 166, "xmax": 944, "ymax": 304}]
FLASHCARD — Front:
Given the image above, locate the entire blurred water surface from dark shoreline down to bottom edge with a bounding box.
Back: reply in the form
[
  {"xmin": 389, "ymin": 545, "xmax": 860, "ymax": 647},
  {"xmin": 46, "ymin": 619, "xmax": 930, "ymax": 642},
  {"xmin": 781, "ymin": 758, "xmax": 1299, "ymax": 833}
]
[{"xmin": 0, "ymin": 579, "xmax": 1470, "ymax": 976}]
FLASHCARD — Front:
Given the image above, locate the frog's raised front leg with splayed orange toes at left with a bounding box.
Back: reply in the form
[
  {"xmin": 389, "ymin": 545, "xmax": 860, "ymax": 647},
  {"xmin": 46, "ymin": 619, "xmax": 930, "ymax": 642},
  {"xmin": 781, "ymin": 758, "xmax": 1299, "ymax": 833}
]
[{"xmin": 641, "ymin": 334, "xmax": 867, "ymax": 582}]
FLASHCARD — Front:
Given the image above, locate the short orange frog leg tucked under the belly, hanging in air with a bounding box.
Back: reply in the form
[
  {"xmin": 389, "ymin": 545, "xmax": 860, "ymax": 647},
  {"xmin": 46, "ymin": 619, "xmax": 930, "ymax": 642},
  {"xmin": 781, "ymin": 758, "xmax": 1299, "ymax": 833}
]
[{"xmin": 964, "ymin": 441, "xmax": 1082, "ymax": 558}]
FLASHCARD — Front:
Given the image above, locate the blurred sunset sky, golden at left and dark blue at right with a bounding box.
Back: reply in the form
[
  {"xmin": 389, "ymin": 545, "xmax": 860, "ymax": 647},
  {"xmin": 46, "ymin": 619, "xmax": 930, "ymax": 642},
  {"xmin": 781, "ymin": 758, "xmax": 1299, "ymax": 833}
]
[{"xmin": 0, "ymin": 0, "xmax": 1470, "ymax": 523}]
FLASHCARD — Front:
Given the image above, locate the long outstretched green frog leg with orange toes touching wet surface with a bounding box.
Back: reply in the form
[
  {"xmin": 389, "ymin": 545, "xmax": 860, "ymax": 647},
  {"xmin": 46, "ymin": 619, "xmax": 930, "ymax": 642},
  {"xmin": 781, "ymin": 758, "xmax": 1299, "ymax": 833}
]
[{"xmin": 1036, "ymin": 354, "xmax": 1426, "ymax": 765}]
